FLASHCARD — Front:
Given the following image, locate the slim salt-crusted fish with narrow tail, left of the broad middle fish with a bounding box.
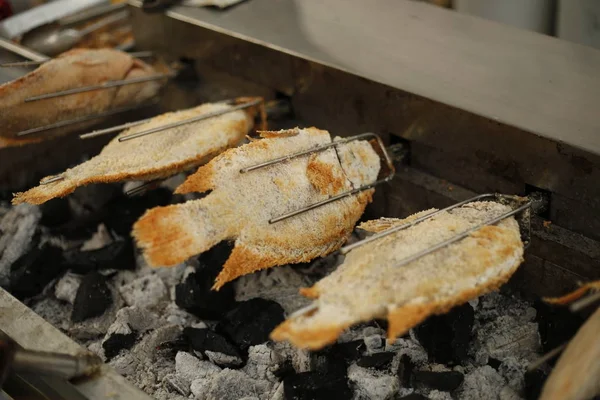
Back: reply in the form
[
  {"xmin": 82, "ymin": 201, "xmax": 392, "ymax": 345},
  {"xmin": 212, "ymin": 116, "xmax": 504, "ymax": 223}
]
[{"xmin": 13, "ymin": 98, "xmax": 256, "ymax": 204}]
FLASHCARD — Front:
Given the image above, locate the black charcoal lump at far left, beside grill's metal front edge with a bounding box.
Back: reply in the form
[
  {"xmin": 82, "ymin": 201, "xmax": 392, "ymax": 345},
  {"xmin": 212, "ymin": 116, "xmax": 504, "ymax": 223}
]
[{"xmin": 9, "ymin": 241, "xmax": 66, "ymax": 300}]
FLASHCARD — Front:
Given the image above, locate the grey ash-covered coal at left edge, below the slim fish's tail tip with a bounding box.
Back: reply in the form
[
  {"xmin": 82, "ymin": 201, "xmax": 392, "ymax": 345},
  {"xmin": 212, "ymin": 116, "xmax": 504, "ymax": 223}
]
[{"xmin": 0, "ymin": 204, "xmax": 42, "ymax": 286}]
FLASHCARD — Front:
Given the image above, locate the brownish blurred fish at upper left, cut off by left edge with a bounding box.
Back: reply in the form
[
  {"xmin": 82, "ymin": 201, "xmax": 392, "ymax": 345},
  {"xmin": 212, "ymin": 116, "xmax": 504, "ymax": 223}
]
[{"xmin": 0, "ymin": 49, "xmax": 163, "ymax": 146}]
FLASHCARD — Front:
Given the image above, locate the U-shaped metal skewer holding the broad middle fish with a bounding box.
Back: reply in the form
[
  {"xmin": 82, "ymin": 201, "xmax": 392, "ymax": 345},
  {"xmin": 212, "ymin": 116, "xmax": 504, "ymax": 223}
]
[{"xmin": 264, "ymin": 132, "xmax": 395, "ymax": 224}]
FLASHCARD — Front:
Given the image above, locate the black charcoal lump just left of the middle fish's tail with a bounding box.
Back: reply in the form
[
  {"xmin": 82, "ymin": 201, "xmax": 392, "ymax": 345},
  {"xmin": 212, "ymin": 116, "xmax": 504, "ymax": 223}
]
[{"xmin": 101, "ymin": 188, "xmax": 171, "ymax": 237}]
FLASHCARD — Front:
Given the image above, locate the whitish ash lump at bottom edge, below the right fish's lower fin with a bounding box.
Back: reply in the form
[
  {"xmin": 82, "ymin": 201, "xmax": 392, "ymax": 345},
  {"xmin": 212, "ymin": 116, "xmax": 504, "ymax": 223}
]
[{"xmin": 348, "ymin": 364, "xmax": 400, "ymax": 400}]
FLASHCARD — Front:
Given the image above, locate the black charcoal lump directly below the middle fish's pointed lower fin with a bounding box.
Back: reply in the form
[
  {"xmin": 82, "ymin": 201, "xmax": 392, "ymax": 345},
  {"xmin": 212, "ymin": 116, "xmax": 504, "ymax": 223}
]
[{"xmin": 217, "ymin": 298, "xmax": 284, "ymax": 351}]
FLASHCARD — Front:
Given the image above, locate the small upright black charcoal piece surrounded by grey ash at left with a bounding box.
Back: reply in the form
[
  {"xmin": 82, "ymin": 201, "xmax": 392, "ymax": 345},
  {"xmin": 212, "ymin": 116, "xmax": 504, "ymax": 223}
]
[{"xmin": 71, "ymin": 271, "xmax": 113, "ymax": 322}]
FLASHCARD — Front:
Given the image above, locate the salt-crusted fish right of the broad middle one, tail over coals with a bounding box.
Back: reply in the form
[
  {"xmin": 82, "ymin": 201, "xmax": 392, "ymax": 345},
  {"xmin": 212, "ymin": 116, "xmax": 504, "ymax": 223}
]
[{"xmin": 271, "ymin": 202, "xmax": 523, "ymax": 349}]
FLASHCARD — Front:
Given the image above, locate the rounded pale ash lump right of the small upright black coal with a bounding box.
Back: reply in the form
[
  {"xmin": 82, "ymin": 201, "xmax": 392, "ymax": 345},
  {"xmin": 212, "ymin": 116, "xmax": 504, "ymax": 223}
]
[{"xmin": 119, "ymin": 274, "xmax": 168, "ymax": 308}]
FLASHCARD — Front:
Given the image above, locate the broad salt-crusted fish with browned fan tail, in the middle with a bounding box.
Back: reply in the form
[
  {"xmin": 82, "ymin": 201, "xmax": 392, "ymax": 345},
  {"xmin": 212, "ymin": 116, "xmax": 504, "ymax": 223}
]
[{"xmin": 133, "ymin": 128, "xmax": 380, "ymax": 288}]
